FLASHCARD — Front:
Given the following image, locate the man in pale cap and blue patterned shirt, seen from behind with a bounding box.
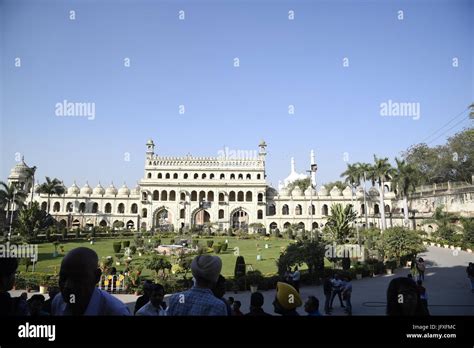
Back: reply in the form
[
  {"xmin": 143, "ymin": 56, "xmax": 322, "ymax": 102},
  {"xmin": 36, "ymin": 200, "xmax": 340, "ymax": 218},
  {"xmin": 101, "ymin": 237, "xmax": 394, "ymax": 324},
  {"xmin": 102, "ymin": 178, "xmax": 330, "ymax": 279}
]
[{"xmin": 168, "ymin": 255, "xmax": 227, "ymax": 316}]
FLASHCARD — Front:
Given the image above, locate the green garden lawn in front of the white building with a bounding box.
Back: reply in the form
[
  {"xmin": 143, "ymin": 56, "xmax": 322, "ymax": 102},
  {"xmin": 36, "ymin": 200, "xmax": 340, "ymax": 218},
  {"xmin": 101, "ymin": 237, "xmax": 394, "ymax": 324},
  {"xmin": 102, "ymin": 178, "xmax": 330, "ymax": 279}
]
[{"xmin": 27, "ymin": 237, "xmax": 298, "ymax": 276}]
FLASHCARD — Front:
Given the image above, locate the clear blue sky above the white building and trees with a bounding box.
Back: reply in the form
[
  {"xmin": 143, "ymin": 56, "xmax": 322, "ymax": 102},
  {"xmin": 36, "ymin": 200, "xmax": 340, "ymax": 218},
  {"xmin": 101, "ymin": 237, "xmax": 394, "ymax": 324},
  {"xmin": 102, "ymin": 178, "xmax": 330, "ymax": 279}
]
[{"xmin": 0, "ymin": 0, "xmax": 474, "ymax": 186}]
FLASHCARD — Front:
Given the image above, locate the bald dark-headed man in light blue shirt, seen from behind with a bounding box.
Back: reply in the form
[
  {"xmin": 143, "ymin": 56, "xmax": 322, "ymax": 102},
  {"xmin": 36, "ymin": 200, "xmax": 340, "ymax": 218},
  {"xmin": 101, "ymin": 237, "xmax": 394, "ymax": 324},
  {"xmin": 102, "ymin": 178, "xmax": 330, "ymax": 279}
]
[{"xmin": 51, "ymin": 247, "xmax": 131, "ymax": 316}]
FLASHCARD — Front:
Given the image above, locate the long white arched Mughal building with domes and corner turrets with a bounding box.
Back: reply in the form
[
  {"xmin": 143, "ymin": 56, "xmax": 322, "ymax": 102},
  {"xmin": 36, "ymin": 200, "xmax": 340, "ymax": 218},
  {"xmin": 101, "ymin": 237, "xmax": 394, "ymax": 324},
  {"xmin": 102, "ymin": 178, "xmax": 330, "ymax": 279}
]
[{"xmin": 8, "ymin": 140, "xmax": 474, "ymax": 233}]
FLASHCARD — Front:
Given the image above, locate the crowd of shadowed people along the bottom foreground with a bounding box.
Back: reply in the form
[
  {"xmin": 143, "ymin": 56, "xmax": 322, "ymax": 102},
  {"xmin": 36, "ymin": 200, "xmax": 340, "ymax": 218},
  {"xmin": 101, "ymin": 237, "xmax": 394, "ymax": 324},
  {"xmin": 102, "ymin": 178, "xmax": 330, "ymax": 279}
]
[{"xmin": 0, "ymin": 247, "xmax": 474, "ymax": 316}]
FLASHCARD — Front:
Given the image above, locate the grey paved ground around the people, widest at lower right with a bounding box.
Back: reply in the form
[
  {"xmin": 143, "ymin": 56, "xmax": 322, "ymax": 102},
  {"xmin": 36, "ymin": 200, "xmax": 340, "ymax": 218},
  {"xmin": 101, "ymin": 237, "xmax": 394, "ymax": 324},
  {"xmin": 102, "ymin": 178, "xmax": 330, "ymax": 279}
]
[{"xmin": 12, "ymin": 247, "xmax": 474, "ymax": 315}]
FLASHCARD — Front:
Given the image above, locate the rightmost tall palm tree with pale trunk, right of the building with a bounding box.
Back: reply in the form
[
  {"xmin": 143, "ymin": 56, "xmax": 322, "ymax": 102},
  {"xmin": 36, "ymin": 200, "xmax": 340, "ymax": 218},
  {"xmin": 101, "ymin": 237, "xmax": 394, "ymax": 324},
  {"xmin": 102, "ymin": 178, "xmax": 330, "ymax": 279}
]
[{"xmin": 393, "ymin": 157, "xmax": 420, "ymax": 227}]
